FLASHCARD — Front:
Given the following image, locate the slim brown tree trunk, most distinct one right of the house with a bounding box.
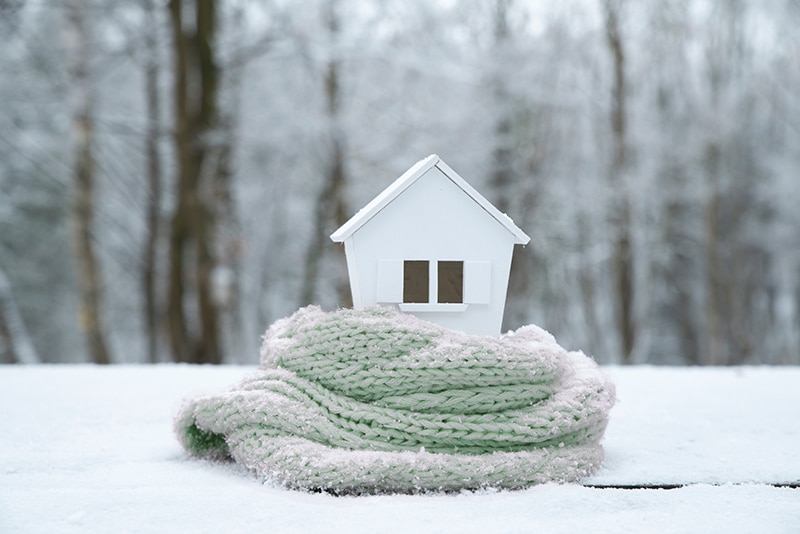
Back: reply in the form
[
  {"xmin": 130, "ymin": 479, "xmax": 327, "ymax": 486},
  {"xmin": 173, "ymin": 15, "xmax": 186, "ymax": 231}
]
[{"xmin": 603, "ymin": 0, "xmax": 635, "ymax": 364}]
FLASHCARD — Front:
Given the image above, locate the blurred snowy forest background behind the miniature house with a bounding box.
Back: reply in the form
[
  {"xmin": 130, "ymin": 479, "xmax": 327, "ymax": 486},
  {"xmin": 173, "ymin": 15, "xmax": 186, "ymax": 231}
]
[{"xmin": 0, "ymin": 0, "xmax": 800, "ymax": 365}]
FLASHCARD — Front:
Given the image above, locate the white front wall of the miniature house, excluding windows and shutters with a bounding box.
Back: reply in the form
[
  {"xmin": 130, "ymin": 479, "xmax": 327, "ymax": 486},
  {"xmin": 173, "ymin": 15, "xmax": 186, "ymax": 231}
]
[{"xmin": 345, "ymin": 167, "xmax": 514, "ymax": 335}]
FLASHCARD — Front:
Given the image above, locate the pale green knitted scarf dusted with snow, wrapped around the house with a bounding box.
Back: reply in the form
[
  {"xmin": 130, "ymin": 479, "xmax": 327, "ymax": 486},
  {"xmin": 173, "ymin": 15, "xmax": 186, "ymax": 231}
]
[{"xmin": 175, "ymin": 306, "xmax": 614, "ymax": 493}]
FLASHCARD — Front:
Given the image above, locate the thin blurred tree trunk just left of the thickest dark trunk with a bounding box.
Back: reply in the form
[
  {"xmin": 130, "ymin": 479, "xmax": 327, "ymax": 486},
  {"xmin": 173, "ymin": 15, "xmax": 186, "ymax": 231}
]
[{"xmin": 142, "ymin": 0, "xmax": 162, "ymax": 363}]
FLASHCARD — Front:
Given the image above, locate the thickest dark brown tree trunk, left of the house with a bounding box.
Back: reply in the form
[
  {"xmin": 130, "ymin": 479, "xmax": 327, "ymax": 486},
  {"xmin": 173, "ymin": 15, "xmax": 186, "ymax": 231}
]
[{"xmin": 167, "ymin": 0, "xmax": 222, "ymax": 363}]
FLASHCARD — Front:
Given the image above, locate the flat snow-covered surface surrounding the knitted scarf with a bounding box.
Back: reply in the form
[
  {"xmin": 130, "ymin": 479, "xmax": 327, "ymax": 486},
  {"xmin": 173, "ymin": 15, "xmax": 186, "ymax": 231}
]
[{"xmin": 0, "ymin": 365, "xmax": 800, "ymax": 534}]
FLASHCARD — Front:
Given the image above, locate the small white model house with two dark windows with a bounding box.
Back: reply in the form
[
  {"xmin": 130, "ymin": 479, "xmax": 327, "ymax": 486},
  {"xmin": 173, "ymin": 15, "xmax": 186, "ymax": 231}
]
[{"xmin": 331, "ymin": 154, "xmax": 530, "ymax": 335}]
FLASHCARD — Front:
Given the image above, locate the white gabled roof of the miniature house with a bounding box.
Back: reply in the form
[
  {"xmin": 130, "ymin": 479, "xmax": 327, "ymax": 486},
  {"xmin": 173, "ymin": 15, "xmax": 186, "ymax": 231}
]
[{"xmin": 331, "ymin": 154, "xmax": 531, "ymax": 245}]
